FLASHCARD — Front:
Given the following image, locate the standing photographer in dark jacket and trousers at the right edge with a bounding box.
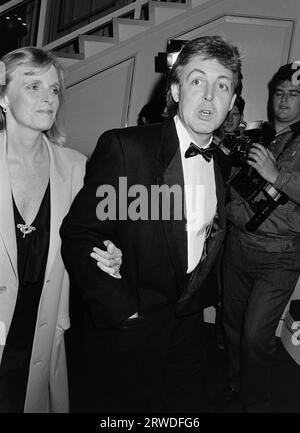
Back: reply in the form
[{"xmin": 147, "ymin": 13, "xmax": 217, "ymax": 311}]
[{"xmin": 223, "ymin": 64, "xmax": 300, "ymax": 412}]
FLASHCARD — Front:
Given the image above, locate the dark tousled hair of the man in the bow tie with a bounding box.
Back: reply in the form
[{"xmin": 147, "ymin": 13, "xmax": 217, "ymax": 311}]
[{"xmin": 167, "ymin": 35, "xmax": 243, "ymax": 116}]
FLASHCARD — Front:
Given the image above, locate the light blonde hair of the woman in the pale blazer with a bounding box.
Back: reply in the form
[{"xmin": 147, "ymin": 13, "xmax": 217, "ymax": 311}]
[{"xmin": 0, "ymin": 47, "xmax": 65, "ymax": 146}]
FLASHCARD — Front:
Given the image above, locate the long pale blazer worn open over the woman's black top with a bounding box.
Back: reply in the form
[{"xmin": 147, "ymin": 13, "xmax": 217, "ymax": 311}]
[{"xmin": 0, "ymin": 132, "xmax": 86, "ymax": 412}]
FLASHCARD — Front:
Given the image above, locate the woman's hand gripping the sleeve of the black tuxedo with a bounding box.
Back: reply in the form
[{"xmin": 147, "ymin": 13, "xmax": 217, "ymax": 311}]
[{"xmin": 90, "ymin": 240, "xmax": 122, "ymax": 278}]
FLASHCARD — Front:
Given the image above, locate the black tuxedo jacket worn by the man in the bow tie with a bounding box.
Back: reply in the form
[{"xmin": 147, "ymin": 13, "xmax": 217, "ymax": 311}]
[{"xmin": 60, "ymin": 119, "xmax": 226, "ymax": 327}]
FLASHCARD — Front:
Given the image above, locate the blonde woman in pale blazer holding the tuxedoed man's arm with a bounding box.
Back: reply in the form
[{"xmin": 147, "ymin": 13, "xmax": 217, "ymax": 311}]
[{"xmin": 0, "ymin": 47, "xmax": 121, "ymax": 412}]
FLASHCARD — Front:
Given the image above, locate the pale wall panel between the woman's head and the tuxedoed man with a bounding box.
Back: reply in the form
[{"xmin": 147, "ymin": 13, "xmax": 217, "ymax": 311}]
[{"xmin": 62, "ymin": 57, "xmax": 135, "ymax": 156}]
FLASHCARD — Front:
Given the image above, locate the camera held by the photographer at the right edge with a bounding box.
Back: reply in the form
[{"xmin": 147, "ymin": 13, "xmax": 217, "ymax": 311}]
[{"xmin": 230, "ymin": 122, "xmax": 288, "ymax": 232}]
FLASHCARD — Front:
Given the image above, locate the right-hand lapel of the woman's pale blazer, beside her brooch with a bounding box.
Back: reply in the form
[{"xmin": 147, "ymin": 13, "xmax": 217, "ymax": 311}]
[{"xmin": 44, "ymin": 137, "xmax": 69, "ymax": 281}]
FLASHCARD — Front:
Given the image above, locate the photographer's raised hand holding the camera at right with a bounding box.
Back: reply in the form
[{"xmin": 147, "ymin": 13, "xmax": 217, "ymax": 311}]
[{"xmin": 247, "ymin": 143, "xmax": 279, "ymax": 184}]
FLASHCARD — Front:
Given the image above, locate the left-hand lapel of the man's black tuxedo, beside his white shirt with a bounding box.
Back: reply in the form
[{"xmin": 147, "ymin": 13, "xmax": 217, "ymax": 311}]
[{"xmin": 157, "ymin": 119, "xmax": 187, "ymax": 279}]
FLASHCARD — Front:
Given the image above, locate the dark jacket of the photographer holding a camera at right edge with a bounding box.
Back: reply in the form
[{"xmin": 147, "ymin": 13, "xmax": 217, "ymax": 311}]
[{"xmin": 227, "ymin": 122, "xmax": 300, "ymax": 252}]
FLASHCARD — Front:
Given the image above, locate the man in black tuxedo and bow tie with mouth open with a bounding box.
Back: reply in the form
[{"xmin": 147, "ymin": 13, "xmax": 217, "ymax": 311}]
[{"xmin": 61, "ymin": 36, "xmax": 241, "ymax": 412}]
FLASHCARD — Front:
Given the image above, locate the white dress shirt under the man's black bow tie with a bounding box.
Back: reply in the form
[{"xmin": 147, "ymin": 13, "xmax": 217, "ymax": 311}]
[{"xmin": 174, "ymin": 115, "xmax": 217, "ymax": 273}]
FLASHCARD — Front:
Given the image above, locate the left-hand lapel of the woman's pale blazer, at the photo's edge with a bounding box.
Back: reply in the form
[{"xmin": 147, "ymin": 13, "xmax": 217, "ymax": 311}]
[{"xmin": 0, "ymin": 131, "xmax": 18, "ymax": 287}]
